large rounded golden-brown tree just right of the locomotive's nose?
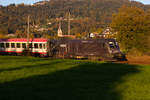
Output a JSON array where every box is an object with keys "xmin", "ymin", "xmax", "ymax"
[{"xmin": 111, "ymin": 6, "xmax": 150, "ymax": 52}]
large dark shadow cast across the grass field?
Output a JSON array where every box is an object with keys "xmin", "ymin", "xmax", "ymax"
[{"xmin": 0, "ymin": 62, "xmax": 139, "ymax": 100}]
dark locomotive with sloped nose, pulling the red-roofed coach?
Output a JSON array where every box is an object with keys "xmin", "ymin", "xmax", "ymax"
[{"xmin": 48, "ymin": 39, "xmax": 127, "ymax": 61}]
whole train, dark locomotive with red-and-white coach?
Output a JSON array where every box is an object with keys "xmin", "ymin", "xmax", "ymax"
[{"xmin": 0, "ymin": 38, "xmax": 127, "ymax": 61}]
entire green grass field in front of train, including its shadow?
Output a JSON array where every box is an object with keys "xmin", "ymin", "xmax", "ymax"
[{"xmin": 0, "ymin": 56, "xmax": 150, "ymax": 100}]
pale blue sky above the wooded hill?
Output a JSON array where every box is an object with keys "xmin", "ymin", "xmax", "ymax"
[{"xmin": 0, "ymin": 0, "xmax": 150, "ymax": 6}]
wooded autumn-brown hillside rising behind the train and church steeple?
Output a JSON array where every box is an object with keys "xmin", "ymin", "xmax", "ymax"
[{"xmin": 0, "ymin": 0, "xmax": 149, "ymax": 36}]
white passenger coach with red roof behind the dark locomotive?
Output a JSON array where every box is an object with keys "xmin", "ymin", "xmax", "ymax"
[{"xmin": 0, "ymin": 38, "xmax": 48, "ymax": 56}]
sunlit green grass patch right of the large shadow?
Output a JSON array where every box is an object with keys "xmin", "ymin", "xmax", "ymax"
[{"xmin": 116, "ymin": 65, "xmax": 150, "ymax": 100}]
